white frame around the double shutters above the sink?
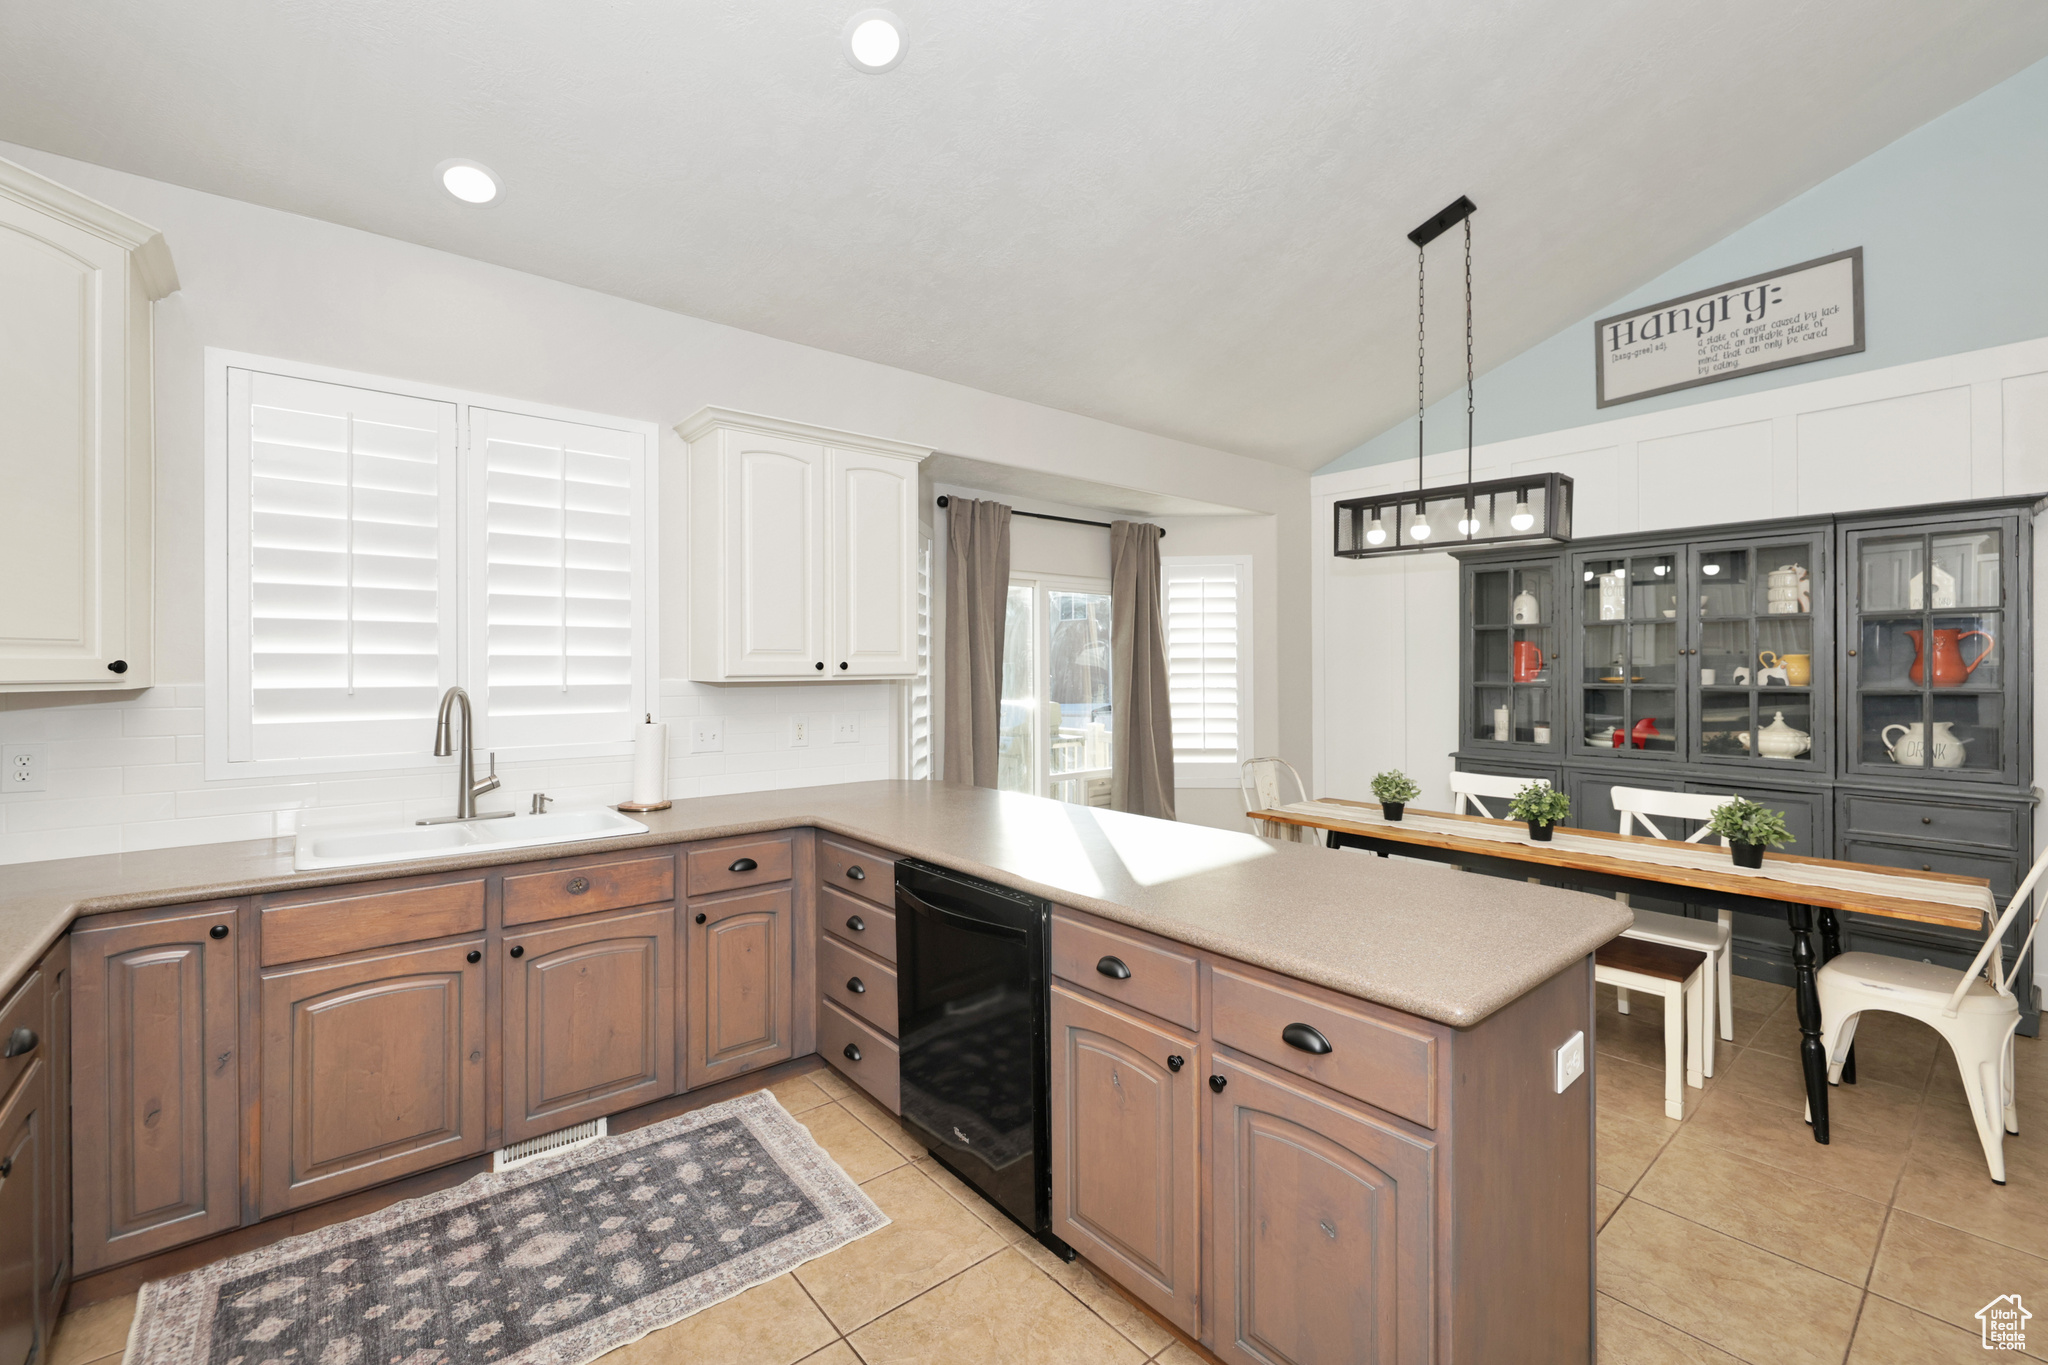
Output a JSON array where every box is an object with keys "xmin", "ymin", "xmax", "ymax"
[{"xmin": 205, "ymin": 346, "xmax": 662, "ymax": 782}]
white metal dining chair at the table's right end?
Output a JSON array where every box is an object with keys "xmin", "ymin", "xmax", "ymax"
[{"xmin": 1817, "ymin": 851, "xmax": 2048, "ymax": 1185}]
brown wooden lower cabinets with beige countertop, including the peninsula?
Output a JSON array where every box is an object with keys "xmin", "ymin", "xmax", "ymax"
[{"xmin": 0, "ymin": 782, "xmax": 1630, "ymax": 1361}]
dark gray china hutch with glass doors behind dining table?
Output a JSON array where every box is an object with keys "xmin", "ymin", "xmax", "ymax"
[{"xmin": 1452, "ymin": 497, "xmax": 2042, "ymax": 1033}]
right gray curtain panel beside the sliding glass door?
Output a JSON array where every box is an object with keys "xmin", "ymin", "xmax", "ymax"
[{"xmin": 1110, "ymin": 522, "xmax": 1174, "ymax": 821}]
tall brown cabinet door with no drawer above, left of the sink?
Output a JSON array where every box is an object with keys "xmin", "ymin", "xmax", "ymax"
[{"xmin": 72, "ymin": 902, "xmax": 242, "ymax": 1273}]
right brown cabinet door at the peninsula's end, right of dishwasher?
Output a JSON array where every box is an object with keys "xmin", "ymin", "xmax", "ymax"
[{"xmin": 1210, "ymin": 1058, "xmax": 1434, "ymax": 1365}]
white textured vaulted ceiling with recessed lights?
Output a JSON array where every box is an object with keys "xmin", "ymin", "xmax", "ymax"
[{"xmin": 0, "ymin": 0, "xmax": 2048, "ymax": 469}]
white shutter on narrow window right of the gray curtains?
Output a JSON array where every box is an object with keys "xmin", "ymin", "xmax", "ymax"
[{"xmin": 1161, "ymin": 559, "xmax": 1245, "ymax": 772}]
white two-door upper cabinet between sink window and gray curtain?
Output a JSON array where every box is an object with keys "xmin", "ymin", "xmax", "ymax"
[{"xmin": 676, "ymin": 407, "xmax": 930, "ymax": 681}]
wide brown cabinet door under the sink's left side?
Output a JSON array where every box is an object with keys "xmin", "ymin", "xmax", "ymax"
[{"xmin": 258, "ymin": 939, "xmax": 483, "ymax": 1218}]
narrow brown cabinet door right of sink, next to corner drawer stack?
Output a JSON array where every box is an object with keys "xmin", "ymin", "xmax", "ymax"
[{"xmin": 688, "ymin": 886, "xmax": 795, "ymax": 1087}]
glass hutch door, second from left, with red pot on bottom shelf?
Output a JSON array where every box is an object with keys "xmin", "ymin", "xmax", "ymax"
[{"xmin": 1573, "ymin": 546, "xmax": 1686, "ymax": 759}]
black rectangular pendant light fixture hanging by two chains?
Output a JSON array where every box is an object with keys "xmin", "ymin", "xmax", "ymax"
[{"xmin": 1335, "ymin": 194, "xmax": 1571, "ymax": 559}]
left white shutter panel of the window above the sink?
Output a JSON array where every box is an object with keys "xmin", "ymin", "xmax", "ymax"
[{"xmin": 225, "ymin": 368, "xmax": 459, "ymax": 767}]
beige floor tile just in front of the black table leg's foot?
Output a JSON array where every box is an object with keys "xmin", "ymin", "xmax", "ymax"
[{"xmin": 1630, "ymin": 1134, "xmax": 1884, "ymax": 1285}]
